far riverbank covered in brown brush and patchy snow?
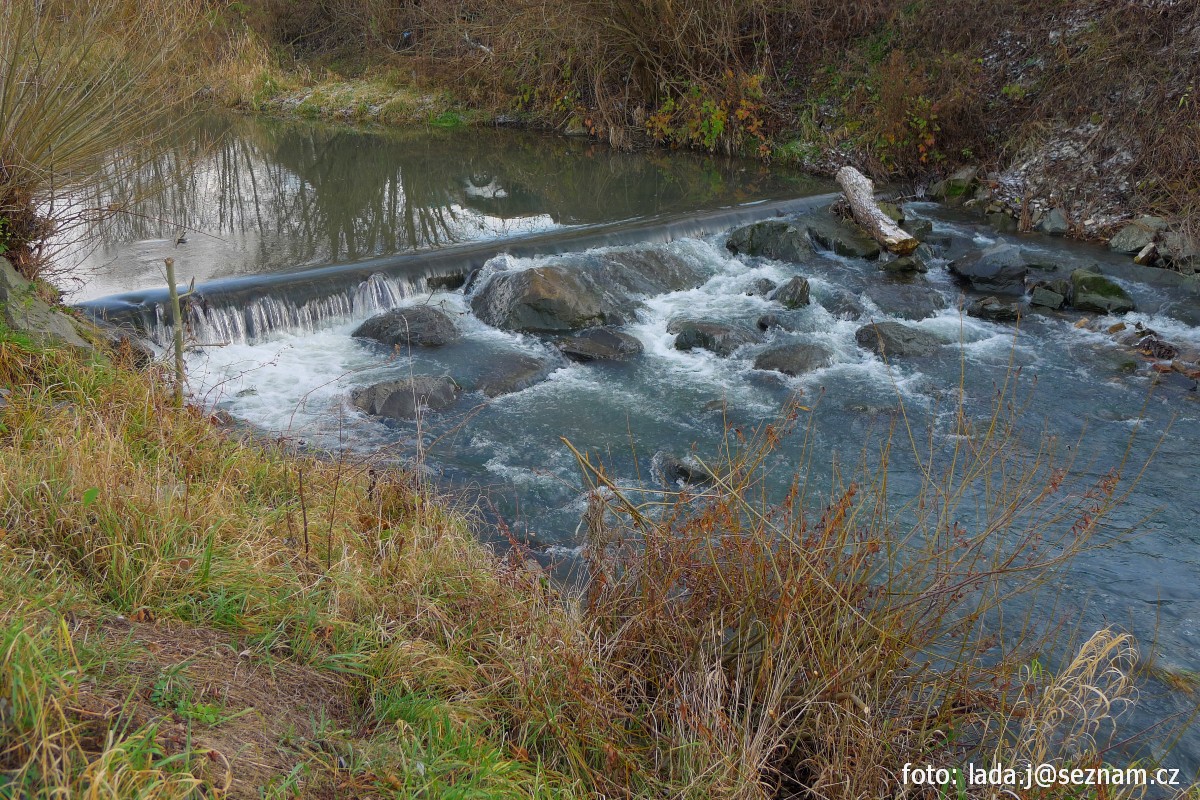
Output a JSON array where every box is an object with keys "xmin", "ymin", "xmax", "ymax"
[{"xmin": 208, "ymin": 0, "xmax": 1200, "ymax": 273}]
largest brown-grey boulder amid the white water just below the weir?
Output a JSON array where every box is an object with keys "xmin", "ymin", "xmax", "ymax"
[{"xmin": 470, "ymin": 247, "xmax": 706, "ymax": 333}]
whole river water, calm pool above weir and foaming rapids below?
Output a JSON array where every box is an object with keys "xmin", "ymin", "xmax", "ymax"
[{"xmin": 77, "ymin": 112, "xmax": 1200, "ymax": 775}]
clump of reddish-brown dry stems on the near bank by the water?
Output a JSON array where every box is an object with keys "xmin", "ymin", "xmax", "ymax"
[{"xmin": 559, "ymin": 381, "xmax": 1152, "ymax": 798}]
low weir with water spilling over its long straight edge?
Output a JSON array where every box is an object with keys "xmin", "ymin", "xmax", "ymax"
[{"xmin": 78, "ymin": 194, "xmax": 836, "ymax": 344}]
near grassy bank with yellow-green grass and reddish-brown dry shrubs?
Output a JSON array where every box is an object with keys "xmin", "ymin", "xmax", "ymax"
[{"xmin": 0, "ymin": 316, "xmax": 1180, "ymax": 798}]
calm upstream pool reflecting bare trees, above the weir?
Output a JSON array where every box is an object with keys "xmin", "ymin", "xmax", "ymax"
[{"xmin": 71, "ymin": 116, "xmax": 814, "ymax": 301}]
